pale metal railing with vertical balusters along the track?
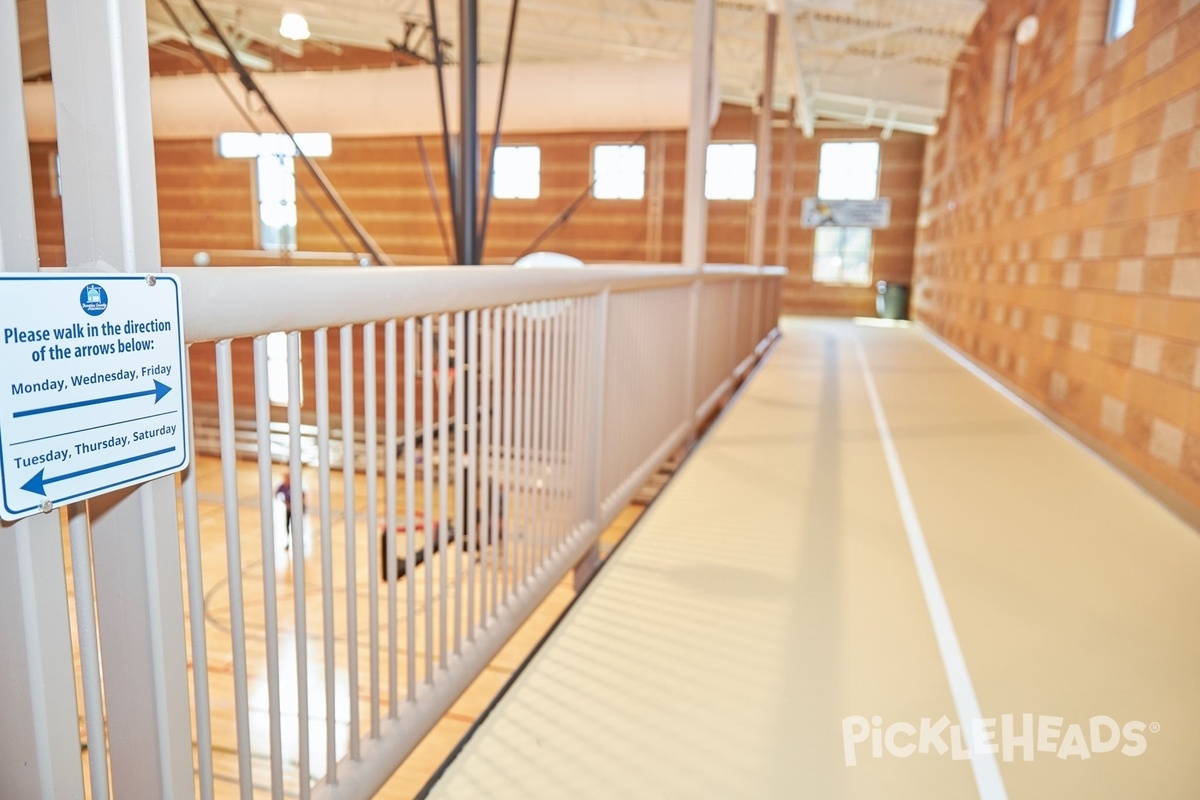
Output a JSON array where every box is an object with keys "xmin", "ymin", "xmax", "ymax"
[{"xmin": 121, "ymin": 267, "xmax": 781, "ymax": 798}]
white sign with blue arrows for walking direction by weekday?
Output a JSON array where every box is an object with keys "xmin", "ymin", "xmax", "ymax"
[{"xmin": 0, "ymin": 272, "xmax": 190, "ymax": 519}]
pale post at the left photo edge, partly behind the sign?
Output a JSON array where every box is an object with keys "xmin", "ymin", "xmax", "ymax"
[{"xmin": 0, "ymin": 0, "xmax": 84, "ymax": 800}]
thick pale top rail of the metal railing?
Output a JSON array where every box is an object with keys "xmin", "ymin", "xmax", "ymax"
[{"xmin": 164, "ymin": 265, "xmax": 782, "ymax": 342}]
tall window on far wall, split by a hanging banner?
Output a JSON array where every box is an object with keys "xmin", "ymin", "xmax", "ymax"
[{"xmin": 812, "ymin": 142, "xmax": 880, "ymax": 285}]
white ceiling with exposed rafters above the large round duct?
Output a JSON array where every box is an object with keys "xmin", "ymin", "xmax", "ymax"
[{"xmin": 17, "ymin": 0, "xmax": 985, "ymax": 136}]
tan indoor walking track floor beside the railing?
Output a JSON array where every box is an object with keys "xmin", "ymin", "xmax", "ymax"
[{"xmin": 426, "ymin": 319, "xmax": 1200, "ymax": 800}]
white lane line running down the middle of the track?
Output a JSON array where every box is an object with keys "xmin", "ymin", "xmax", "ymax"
[{"xmin": 854, "ymin": 337, "xmax": 1008, "ymax": 800}]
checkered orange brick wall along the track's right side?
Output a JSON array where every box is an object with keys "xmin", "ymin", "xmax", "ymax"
[{"xmin": 914, "ymin": 0, "xmax": 1200, "ymax": 513}]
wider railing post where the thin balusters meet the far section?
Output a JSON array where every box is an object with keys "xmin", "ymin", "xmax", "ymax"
[{"xmin": 575, "ymin": 289, "xmax": 610, "ymax": 591}]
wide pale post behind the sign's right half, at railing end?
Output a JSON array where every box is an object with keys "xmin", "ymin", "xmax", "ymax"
[{"xmin": 47, "ymin": 0, "xmax": 194, "ymax": 800}]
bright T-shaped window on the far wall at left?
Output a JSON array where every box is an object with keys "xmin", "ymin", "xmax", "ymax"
[{"xmin": 217, "ymin": 133, "xmax": 334, "ymax": 252}]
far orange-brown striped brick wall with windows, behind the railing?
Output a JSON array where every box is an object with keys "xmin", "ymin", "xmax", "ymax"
[{"xmin": 31, "ymin": 106, "xmax": 925, "ymax": 315}]
